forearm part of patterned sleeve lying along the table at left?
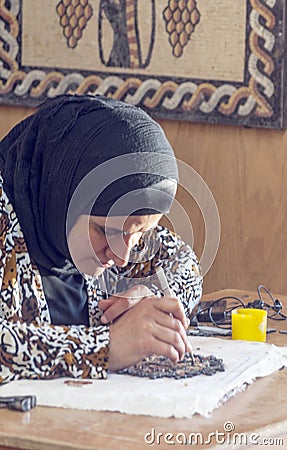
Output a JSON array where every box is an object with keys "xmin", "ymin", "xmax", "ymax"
[{"xmin": 0, "ymin": 319, "xmax": 109, "ymax": 383}]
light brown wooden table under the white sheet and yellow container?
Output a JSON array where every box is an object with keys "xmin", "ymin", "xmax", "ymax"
[{"xmin": 0, "ymin": 290, "xmax": 287, "ymax": 450}]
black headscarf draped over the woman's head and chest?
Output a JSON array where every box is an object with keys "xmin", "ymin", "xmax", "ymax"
[{"xmin": 0, "ymin": 95, "xmax": 178, "ymax": 323}]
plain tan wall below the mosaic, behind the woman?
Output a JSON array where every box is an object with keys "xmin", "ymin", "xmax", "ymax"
[{"xmin": 0, "ymin": 106, "xmax": 287, "ymax": 294}]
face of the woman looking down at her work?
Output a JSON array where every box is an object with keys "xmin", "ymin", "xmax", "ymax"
[{"xmin": 68, "ymin": 214, "xmax": 162, "ymax": 276}]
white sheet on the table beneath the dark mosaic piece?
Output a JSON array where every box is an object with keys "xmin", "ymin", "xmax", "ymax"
[{"xmin": 0, "ymin": 337, "xmax": 287, "ymax": 418}]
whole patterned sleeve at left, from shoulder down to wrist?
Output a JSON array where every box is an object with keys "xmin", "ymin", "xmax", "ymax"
[{"xmin": 0, "ymin": 186, "xmax": 109, "ymax": 384}]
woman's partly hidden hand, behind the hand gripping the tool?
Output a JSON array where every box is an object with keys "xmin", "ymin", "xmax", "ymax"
[{"xmin": 99, "ymin": 285, "xmax": 154, "ymax": 324}]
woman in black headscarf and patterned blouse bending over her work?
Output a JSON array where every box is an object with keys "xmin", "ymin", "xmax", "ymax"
[{"xmin": 0, "ymin": 95, "xmax": 202, "ymax": 382}]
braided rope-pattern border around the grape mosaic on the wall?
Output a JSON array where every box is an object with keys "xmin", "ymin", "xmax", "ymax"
[{"xmin": 0, "ymin": 0, "xmax": 286, "ymax": 128}]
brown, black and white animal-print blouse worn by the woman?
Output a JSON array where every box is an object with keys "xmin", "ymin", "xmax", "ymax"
[{"xmin": 0, "ymin": 175, "xmax": 202, "ymax": 384}]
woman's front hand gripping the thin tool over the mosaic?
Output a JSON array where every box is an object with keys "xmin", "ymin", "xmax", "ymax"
[{"xmin": 109, "ymin": 297, "xmax": 191, "ymax": 371}]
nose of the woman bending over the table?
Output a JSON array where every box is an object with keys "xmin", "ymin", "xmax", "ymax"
[{"xmin": 106, "ymin": 233, "xmax": 140, "ymax": 267}]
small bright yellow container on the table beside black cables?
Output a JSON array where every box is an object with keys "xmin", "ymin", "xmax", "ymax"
[{"xmin": 231, "ymin": 308, "xmax": 267, "ymax": 342}]
